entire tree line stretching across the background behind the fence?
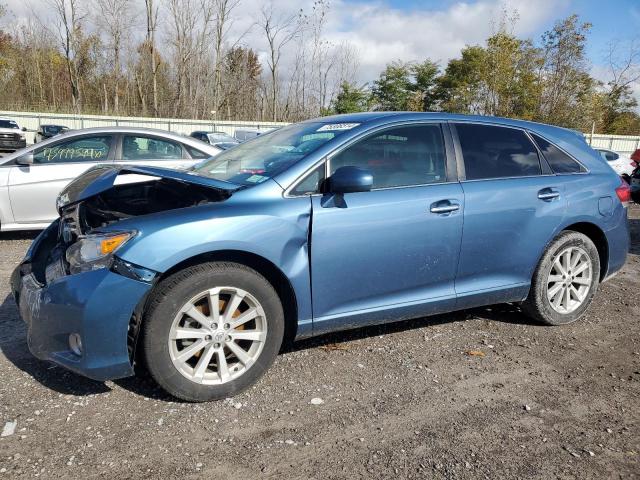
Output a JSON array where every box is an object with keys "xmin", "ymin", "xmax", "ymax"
[{"xmin": 0, "ymin": 0, "xmax": 640, "ymax": 134}]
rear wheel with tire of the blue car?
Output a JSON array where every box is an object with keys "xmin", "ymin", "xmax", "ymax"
[{"xmin": 522, "ymin": 231, "xmax": 600, "ymax": 325}]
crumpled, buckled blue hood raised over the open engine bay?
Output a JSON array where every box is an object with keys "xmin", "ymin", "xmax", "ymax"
[{"xmin": 56, "ymin": 165, "xmax": 241, "ymax": 212}]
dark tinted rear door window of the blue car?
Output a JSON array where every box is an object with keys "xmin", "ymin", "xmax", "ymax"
[{"xmin": 456, "ymin": 123, "xmax": 542, "ymax": 180}]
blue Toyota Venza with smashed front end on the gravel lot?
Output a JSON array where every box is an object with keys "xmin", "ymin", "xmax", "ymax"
[{"xmin": 12, "ymin": 112, "xmax": 629, "ymax": 401}]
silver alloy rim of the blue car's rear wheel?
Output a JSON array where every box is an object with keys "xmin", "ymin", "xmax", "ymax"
[{"xmin": 547, "ymin": 246, "xmax": 593, "ymax": 315}]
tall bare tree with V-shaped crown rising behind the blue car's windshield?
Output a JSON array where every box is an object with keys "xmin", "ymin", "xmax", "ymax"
[{"xmin": 259, "ymin": 4, "xmax": 300, "ymax": 122}]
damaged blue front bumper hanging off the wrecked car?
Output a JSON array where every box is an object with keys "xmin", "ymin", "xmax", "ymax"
[{"xmin": 11, "ymin": 222, "xmax": 153, "ymax": 381}]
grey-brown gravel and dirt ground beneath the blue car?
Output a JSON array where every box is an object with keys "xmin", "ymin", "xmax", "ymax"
[{"xmin": 0, "ymin": 211, "xmax": 640, "ymax": 479}]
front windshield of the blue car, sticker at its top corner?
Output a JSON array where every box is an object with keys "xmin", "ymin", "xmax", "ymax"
[{"xmin": 193, "ymin": 122, "xmax": 358, "ymax": 186}]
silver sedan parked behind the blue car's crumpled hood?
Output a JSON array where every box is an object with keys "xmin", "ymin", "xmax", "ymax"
[{"xmin": 0, "ymin": 127, "xmax": 221, "ymax": 231}]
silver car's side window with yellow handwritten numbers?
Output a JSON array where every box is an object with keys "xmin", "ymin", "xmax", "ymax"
[{"xmin": 33, "ymin": 135, "xmax": 113, "ymax": 164}]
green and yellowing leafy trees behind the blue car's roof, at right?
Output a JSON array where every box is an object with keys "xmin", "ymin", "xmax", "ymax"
[{"xmin": 331, "ymin": 15, "xmax": 640, "ymax": 135}]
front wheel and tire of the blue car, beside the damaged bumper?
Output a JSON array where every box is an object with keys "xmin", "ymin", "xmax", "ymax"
[{"xmin": 142, "ymin": 262, "xmax": 284, "ymax": 402}]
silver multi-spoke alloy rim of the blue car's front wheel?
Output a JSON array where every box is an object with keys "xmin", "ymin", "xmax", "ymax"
[{"xmin": 169, "ymin": 287, "xmax": 267, "ymax": 385}]
